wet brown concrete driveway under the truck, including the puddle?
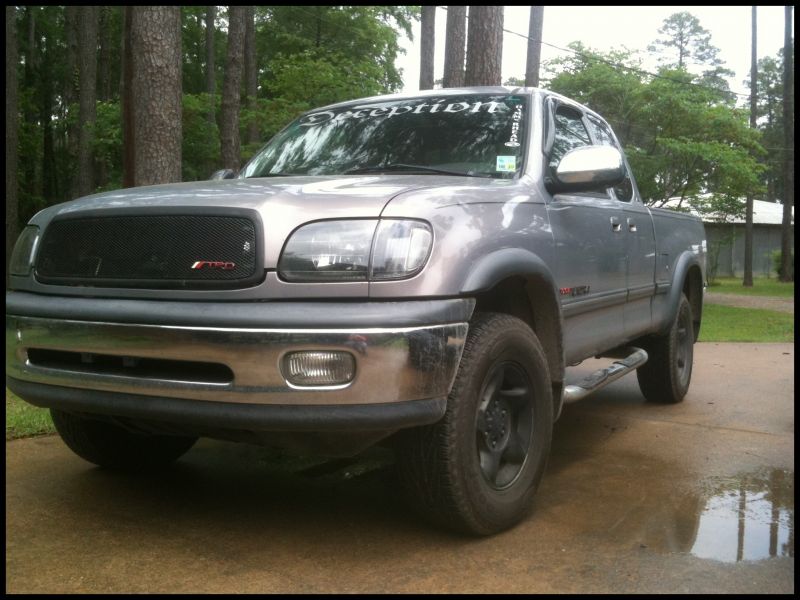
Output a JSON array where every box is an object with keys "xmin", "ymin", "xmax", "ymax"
[{"xmin": 6, "ymin": 344, "xmax": 794, "ymax": 593}]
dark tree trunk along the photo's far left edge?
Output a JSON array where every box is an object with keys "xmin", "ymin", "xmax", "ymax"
[{"xmin": 6, "ymin": 6, "xmax": 19, "ymax": 287}]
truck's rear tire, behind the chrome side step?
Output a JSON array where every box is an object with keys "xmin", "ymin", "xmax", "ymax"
[{"xmin": 636, "ymin": 295, "xmax": 694, "ymax": 404}]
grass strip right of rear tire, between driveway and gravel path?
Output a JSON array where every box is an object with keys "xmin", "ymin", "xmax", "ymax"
[{"xmin": 698, "ymin": 303, "xmax": 794, "ymax": 342}]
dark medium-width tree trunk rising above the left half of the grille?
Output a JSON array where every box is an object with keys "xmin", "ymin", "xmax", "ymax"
[{"xmin": 78, "ymin": 6, "xmax": 97, "ymax": 196}]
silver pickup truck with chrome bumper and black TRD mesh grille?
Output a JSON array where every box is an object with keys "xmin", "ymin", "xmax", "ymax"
[{"xmin": 6, "ymin": 87, "xmax": 706, "ymax": 535}]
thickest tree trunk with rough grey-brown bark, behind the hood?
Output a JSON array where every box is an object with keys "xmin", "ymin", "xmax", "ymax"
[{"xmin": 131, "ymin": 6, "xmax": 183, "ymax": 185}]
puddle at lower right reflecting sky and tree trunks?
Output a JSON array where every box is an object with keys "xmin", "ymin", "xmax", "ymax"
[{"xmin": 691, "ymin": 470, "xmax": 794, "ymax": 562}]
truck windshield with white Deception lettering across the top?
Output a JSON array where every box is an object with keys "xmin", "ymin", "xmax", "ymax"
[{"xmin": 243, "ymin": 94, "xmax": 528, "ymax": 178}]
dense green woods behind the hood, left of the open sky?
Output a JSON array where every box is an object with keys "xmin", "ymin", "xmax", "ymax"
[{"xmin": 6, "ymin": 6, "xmax": 419, "ymax": 223}]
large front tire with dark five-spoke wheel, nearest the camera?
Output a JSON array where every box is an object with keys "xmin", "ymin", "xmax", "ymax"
[{"xmin": 397, "ymin": 313, "xmax": 553, "ymax": 535}]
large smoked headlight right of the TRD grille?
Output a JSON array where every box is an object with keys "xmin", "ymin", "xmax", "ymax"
[{"xmin": 278, "ymin": 219, "xmax": 433, "ymax": 282}]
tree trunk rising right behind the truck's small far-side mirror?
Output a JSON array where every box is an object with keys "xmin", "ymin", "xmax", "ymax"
[{"xmin": 220, "ymin": 6, "xmax": 245, "ymax": 171}]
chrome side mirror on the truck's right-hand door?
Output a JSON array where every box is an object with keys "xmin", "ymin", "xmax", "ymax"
[{"xmin": 547, "ymin": 146, "xmax": 625, "ymax": 194}]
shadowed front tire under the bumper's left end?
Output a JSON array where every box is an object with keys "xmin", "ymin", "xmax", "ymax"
[{"xmin": 50, "ymin": 408, "xmax": 197, "ymax": 470}]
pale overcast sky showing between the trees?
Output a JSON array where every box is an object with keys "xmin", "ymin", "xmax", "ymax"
[{"xmin": 397, "ymin": 6, "xmax": 784, "ymax": 101}]
